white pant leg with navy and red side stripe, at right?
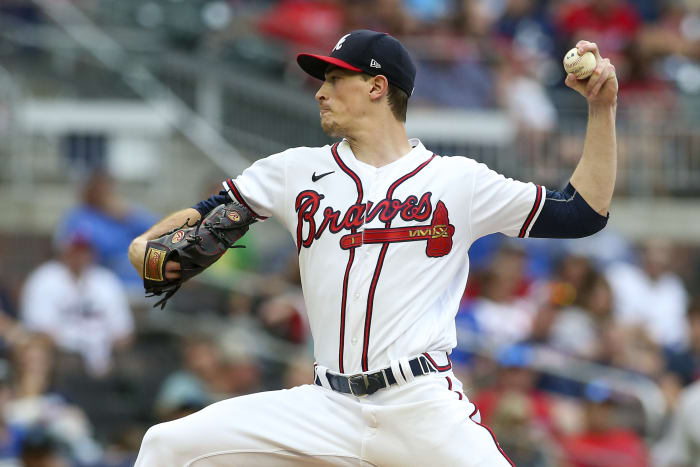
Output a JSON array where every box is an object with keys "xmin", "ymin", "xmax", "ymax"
[{"xmin": 365, "ymin": 372, "xmax": 512, "ymax": 467}]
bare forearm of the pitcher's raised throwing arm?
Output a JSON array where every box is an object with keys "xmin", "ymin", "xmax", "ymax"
[{"xmin": 571, "ymin": 104, "xmax": 617, "ymax": 216}]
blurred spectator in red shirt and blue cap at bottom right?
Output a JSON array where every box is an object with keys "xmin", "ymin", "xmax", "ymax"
[{"xmin": 563, "ymin": 382, "xmax": 648, "ymax": 467}]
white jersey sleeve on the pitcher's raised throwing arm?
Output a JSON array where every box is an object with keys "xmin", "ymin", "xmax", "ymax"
[{"xmin": 470, "ymin": 164, "xmax": 545, "ymax": 240}]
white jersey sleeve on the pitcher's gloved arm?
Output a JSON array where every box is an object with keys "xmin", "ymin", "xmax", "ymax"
[{"xmin": 223, "ymin": 152, "xmax": 287, "ymax": 221}]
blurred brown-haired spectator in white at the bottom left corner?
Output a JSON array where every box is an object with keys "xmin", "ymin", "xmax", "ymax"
[{"xmin": 4, "ymin": 334, "xmax": 101, "ymax": 465}]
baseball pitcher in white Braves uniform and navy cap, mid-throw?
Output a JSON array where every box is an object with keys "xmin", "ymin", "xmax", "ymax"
[{"xmin": 130, "ymin": 30, "xmax": 617, "ymax": 467}]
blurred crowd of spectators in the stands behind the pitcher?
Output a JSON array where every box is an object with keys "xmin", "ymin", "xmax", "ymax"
[{"xmin": 0, "ymin": 0, "xmax": 700, "ymax": 467}]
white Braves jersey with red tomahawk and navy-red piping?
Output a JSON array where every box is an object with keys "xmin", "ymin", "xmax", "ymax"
[{"xmin": 224, "ymin": 139, "xmax": 545, "ymax": 374}]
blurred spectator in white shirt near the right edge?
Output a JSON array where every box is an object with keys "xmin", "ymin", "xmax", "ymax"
[{"xmin": 606, "ymin": 239, "xmax": 688, "ymax": 349}]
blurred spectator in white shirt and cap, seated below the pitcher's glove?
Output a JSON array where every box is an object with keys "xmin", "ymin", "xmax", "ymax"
[{"xmin": 21, "ymin": 232, "xmax": 134, "ymax": 376}]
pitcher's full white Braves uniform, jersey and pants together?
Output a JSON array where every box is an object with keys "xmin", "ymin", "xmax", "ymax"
[{"xmin": 136, "ymin": 140, "xmax": 544, "ymax": 467}]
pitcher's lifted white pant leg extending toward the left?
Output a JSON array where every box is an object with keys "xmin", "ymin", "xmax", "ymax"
[{"xmin": 136, "ymin": 385, "xmax": 371, "ymax": 467}]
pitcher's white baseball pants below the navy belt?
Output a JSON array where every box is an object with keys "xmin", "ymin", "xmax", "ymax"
[{"xmin": 136, "ymin": 371, "xmax": 512, "ymax": 467}]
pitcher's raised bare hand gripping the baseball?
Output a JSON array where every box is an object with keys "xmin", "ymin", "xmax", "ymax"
[{"xmin": 564, "ymin": 41, "xmax": 618, "ymax": 106}]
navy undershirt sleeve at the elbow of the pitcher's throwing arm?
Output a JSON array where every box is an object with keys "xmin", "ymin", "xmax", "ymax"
[{"xmin": 530, "ymin": 183, "xmax": 610, "ymax": 238}]
